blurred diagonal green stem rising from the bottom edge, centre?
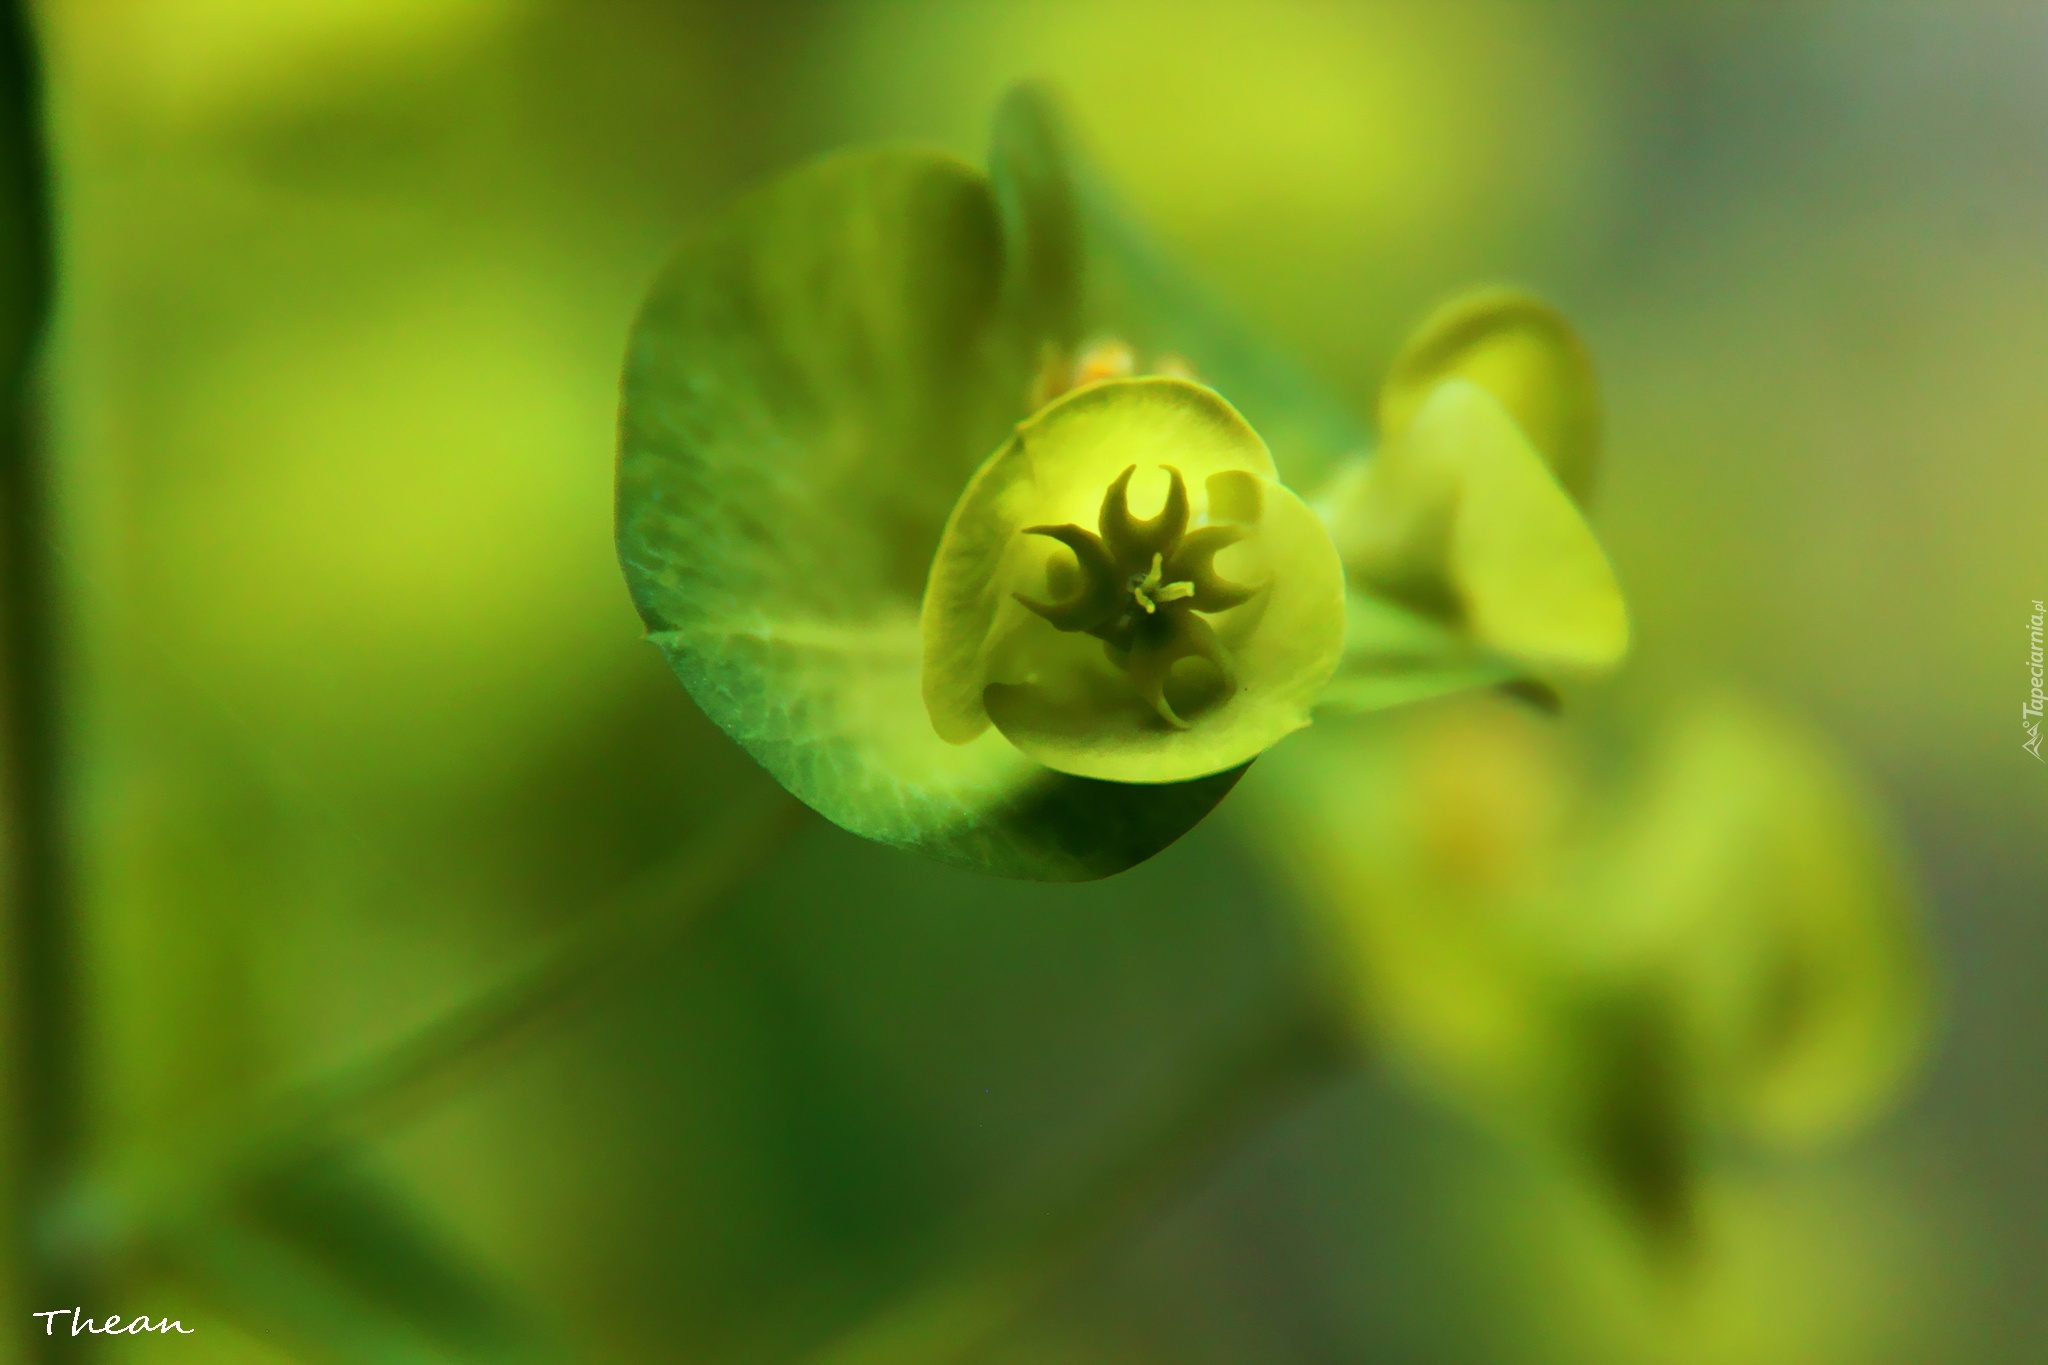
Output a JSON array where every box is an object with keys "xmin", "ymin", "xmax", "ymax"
[{"xmin": 809, "ymin": 999, "xmax": 1358, "ymax": 1365}]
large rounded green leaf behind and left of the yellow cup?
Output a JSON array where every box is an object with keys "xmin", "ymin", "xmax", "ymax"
[{"xmin": 618, "ymin": 151, "xmax": 1235, "ymax": 880}]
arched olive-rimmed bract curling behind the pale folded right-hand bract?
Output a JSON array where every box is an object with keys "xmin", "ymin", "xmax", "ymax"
[{"xmin": 1380, "ymin": 287, "xmax": 1599, "ymax": 508}]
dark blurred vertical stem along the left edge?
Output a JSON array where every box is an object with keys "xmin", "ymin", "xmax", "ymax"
[{"xmin": 0, "ymin": 2, "xmax": 86, "ymax": 1359}]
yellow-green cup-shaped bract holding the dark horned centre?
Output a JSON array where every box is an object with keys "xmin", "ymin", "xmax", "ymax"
[{"xmin": 922, "ymin": 377, "xmax": 1343, "ymax": 784}]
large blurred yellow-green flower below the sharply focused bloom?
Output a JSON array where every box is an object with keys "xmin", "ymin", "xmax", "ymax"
[{"xmin": 1247, "ymin": 700, "xmax": 1929, "ymax": 1234}]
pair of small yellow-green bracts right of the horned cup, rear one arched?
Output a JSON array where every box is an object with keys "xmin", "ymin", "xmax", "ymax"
[{"xmin": 1317, "ymin": 289, "xmax": 1628, "ymax": 710}]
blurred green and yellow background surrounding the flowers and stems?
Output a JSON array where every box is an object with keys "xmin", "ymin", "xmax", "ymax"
[{"xmin": 8, "ymin": 0, "xmax": 2048, "ymax": 1365}]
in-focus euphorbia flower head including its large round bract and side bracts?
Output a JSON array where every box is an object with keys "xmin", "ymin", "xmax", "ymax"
[{"xmin": 618, "ymin": 90, "xmax": 1618, "ymax": 880}]
